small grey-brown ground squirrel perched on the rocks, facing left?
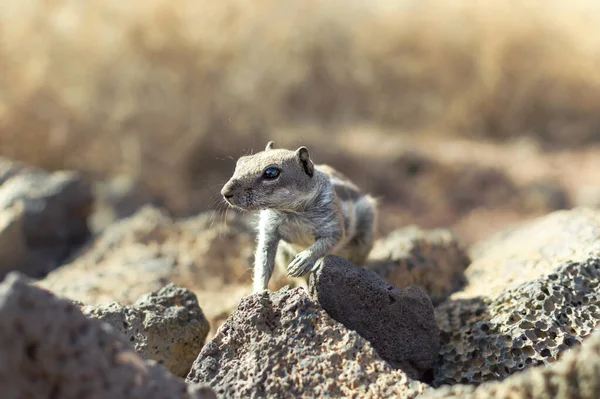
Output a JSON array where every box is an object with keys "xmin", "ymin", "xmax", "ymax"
[{"xmin": 221, "ymin": 141, "xmax": 376, "ymax": 292}]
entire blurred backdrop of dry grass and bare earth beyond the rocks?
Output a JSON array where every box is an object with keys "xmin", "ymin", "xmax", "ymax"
[{"xmin": 0, "ymin": 0, "xmax": 600, "ymax": 243}]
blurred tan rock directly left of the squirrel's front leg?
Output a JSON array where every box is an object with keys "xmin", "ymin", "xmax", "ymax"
[{"xmin": 39, "ymin": 207, "xmax": 254, "ymax": 334}]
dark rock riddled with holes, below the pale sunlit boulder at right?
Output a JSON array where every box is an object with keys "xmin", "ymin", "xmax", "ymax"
[{"xmin": 436, "ymin": 259, "xmax": 600, "ymax": 383}]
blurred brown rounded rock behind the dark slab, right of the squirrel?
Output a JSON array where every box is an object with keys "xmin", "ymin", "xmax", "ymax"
[{"xmin": 365, "ymin": 226, "xmax": 470, "ymax": 304}]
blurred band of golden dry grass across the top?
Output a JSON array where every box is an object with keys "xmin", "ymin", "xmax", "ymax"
[{"xmin": 0, "ymin": 0, "xmax": 600, "ymax": 209}]
